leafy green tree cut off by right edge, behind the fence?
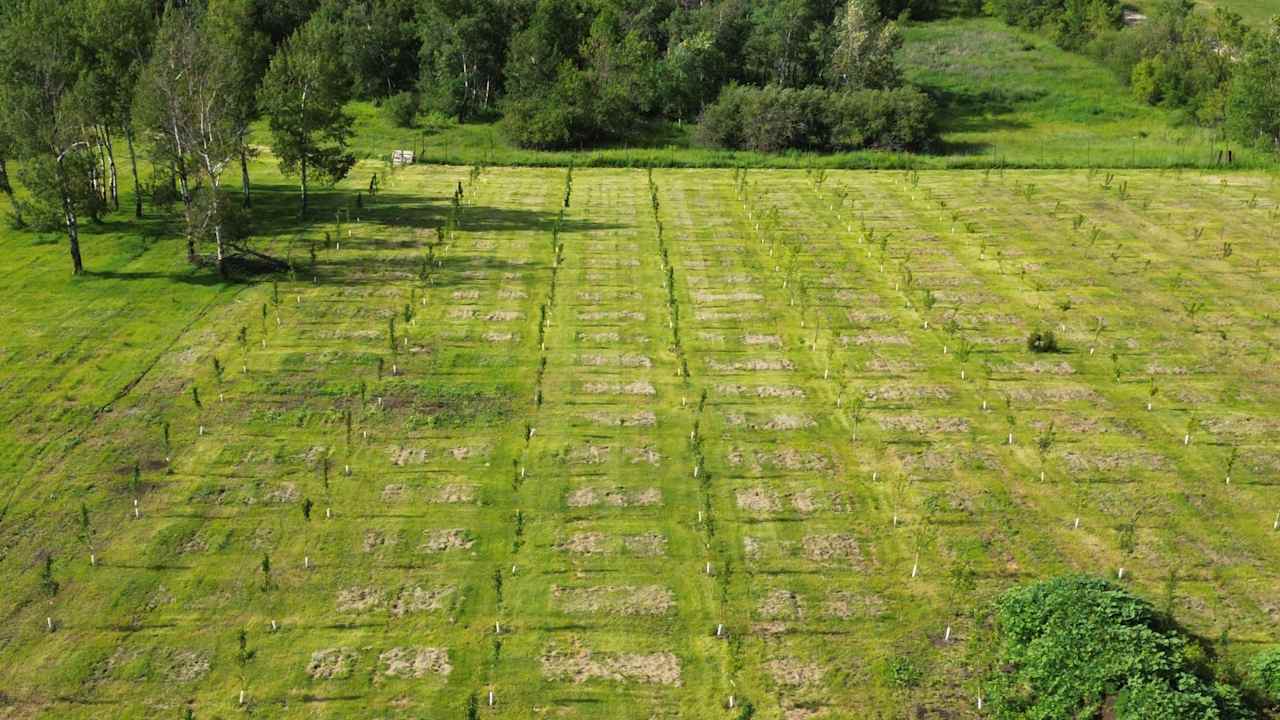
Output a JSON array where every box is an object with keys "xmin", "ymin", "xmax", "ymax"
[{"xmin": 1228, "ymin": 15, "xmax": 1280, "ymax": 152}]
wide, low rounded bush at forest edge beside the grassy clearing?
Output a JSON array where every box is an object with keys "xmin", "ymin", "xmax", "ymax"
[{"xmin": 698, "ymin": 83, "xmax": 934, "ymax": 152}]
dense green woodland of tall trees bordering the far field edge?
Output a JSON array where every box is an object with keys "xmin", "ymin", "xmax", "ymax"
[{"xmin": 0, "ymin": 0, "xmax": 1280, "ymax": 272}]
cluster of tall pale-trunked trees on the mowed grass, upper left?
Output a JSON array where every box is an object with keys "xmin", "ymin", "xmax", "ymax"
[{"xmin": 0, "ymin": 0, "xmax": 355, "ymax": 274}]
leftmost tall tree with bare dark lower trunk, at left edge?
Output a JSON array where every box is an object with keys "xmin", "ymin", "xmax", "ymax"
[{"xmin": 0, "ymin": 0, "xmax": 96, "ymax": 275}]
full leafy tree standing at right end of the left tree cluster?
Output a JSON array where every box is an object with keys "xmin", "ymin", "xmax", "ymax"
[{"xmin": 257, "ymin": 15, "xmax": 356, "ymax": 215}]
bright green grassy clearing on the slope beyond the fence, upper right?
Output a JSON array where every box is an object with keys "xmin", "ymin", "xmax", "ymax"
[{"xmin": 901, "ymin": 18, "xmax": 1267, "ymax": 168}]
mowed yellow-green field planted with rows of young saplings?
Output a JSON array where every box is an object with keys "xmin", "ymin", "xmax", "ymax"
[{"xmin": 0, "ymin": 163, "xmax": 1280, "ymax": 719}]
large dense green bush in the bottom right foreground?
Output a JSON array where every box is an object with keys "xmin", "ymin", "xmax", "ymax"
[{"xmin": 987, "ymin": 575, "xmax": 1253, "ymax": 720}]
